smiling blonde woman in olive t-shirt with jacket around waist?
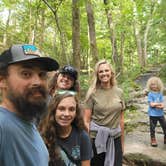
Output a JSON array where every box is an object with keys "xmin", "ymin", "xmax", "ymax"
[{"xmin": 84, "ymin": 60, "xmax": 125, "ymax": 166}]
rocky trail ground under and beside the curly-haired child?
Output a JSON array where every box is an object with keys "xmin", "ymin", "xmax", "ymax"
[{"xmin": 123, "ymin": 67, "xmax": 166, "ymax": 166}]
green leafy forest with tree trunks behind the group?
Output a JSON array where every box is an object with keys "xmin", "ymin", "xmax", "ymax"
[{"xmin": 0, "ymin": 0, "xmax": 166, "ymax": 100}]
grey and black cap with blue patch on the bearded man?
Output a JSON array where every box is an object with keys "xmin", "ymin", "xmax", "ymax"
[{"xmin": 0, "ymin": 44, "xmax": 59, "ymax": 71}]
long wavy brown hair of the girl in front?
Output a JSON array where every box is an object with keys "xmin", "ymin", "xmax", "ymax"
[{"xmin": 39, "ymin": 91, "xmax": 85, "ymax": 166}]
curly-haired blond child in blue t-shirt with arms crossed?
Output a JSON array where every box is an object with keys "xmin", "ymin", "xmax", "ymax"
[{"xmin": 147, "ymin": 77, "xmax": 166, "ymax": 147}]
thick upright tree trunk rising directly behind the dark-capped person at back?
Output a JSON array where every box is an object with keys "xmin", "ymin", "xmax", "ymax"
[{"xmin": 72, "ymin": 0, "xmax": 80, "ymax": 71}]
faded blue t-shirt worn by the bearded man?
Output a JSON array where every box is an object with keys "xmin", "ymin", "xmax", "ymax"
[{"xmin": 0, "ymin": 107, "xmax": 49, "ymax": 166}]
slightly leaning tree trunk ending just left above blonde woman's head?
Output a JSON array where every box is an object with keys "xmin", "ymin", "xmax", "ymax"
[{"xmin": 86, "ymin": 0, "xmax": 98, "ymax": 63}]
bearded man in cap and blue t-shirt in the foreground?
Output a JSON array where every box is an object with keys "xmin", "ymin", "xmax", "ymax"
[{"xmin": 0, "ymin": 44, "xmax": 59, "ymax": 166}]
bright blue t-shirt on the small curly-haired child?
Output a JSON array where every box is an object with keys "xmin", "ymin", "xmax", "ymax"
[{"xmin": 148, "ymin": 92, "xmax": 164, "ymax": 117}]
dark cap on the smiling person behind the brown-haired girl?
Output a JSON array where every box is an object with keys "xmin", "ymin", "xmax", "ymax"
[{"xmin": 59, "ymin": 65, "xmax": 78, "ymax": 80}]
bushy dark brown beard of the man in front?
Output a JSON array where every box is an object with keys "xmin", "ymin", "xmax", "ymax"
[{"xmin": 7, "ymin": 86, "xmax": 48, "ymax": 120}]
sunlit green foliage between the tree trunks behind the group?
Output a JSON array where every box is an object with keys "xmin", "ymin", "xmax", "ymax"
[{"xmin": 0, "ymin": 0, "xmax": 166, "ymax": 79}]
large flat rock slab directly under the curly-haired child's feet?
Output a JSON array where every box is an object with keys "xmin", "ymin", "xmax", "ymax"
[{"xmin": 124, "ymin": 131, "xmax": 166, "ymax": 166}]
